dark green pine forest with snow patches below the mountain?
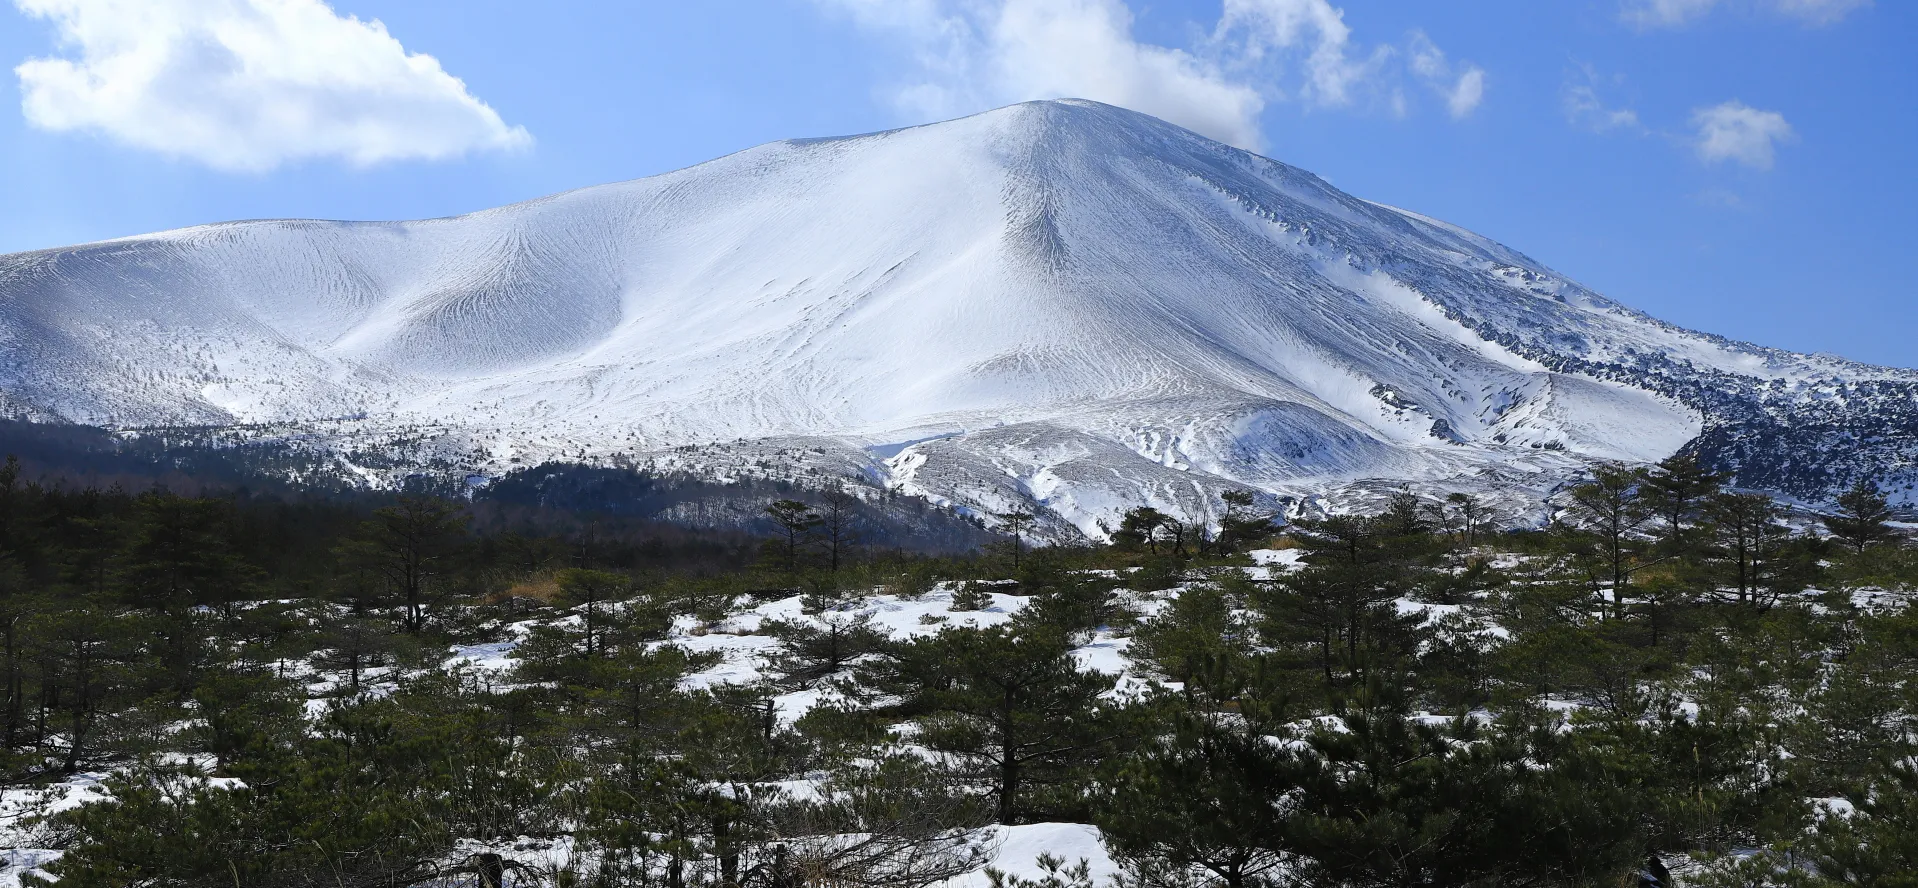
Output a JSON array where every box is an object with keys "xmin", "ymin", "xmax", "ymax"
[{"xmin": 0, "ymin": 458, "xmax": 1918, "ymax": 888}]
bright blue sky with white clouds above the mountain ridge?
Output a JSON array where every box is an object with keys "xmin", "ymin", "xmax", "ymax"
[{"xmin": 0, "ymin": 0, "xmax": 1918, "ymax": 366}]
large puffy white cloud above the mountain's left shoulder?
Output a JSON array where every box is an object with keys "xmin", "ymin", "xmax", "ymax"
[{"xmin": 13, "ymin": 0, "xmax": 531, "ymax": 171}]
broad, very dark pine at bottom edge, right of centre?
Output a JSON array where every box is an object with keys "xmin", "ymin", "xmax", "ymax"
[{"xmin": 1279, "ymin": 694, "xmax": 1642, "ymax": 888}]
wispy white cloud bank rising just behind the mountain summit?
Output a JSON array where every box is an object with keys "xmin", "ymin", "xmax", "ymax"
[{"xmin": 817, "ymin": 0, "xmax": 1485, "ymax": 150}]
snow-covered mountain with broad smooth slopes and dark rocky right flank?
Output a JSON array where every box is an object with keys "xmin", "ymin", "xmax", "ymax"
[{"xmin": 0, "ymin": 100, "xmax": 1918, "ymax": 531}]
